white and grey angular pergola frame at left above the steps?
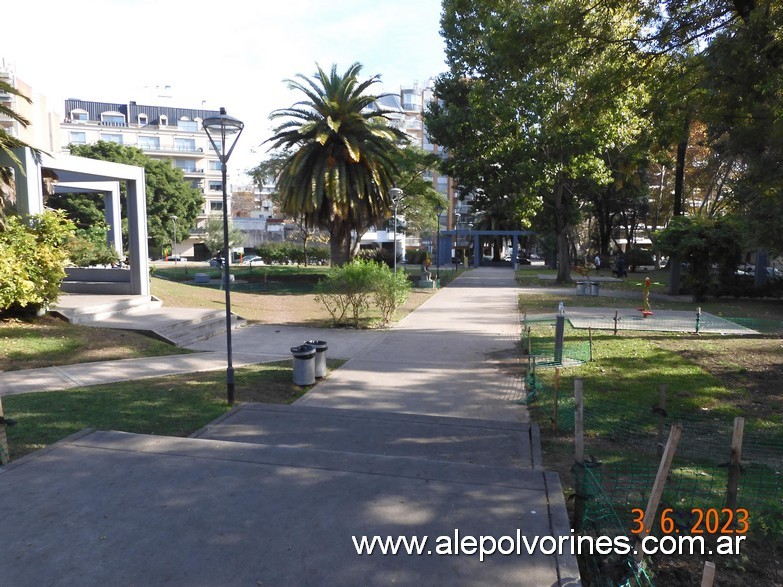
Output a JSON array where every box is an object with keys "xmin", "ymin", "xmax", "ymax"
[{"xmin": 0, "ymin": 149, "xmax": 150, "ymax": 296}]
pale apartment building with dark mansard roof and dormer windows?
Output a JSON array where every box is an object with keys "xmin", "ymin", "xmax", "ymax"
[{"xmin": 59, "ymin": 99, "xmax": 231, "ymax": 259}]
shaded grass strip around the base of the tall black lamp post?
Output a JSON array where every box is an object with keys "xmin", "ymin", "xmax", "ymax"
[{"xmin": 3, "ymin": 360, "xmax": 341, "ymax": 460}]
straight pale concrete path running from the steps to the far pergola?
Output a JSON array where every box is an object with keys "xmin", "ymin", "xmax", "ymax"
[{"xmin": 298, "ymin": 268, "xmax": 527, "ymax": 421}]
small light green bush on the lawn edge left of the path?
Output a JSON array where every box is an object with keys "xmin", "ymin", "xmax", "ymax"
[{"xmin": 315, "ymin": 259, "xmax": 410, "ymax": 328}]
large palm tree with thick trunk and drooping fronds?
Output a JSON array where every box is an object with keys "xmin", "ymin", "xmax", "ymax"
[{"xmin": 267, "ymin": 63, "xmax": 405, "ymax": 265}]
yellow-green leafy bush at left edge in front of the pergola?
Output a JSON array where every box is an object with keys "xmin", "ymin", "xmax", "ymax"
[{"xmin": 0, "ymin": 211, "xmax": 74, "ymax": 311}]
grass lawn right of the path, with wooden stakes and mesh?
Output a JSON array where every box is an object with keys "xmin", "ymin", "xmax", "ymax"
[{"xmin": 518, "ymin": 276, "xmax": 783, "ymax": 585}]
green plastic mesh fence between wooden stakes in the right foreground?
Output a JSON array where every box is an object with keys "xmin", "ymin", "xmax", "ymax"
[{"xmin": 527, "ymin": 374, "xmax": 783, "ymax": 585}]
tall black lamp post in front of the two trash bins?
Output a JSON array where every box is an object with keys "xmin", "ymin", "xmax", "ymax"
[{"xmin": 201, "ymin": 108, "xmax": 245, "ymax": 406}]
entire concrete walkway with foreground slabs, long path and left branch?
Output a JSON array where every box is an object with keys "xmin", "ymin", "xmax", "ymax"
[{"xmin": 0, "ymin": 268, "xmax": 579, "ymax": 587}]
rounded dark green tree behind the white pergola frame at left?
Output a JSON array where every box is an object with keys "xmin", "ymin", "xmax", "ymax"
[{"xmin": 63, "ymin": 141, "xmax": 204, "ymax": 250}]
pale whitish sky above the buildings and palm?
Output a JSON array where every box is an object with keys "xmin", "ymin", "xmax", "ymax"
[{"xmin": 0, "ymin": 0, "xmax": 446, "ymax": 179}]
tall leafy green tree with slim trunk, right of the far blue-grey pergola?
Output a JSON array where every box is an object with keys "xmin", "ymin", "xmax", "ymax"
[{"xmin": 428, "ymin": 0, "xmax": 647, "ymax": 282}]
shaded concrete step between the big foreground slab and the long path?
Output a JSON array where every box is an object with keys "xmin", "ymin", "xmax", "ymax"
[{"xmin": 192, "ymin": 403, "xmax": 541, "ymax": 470}]
